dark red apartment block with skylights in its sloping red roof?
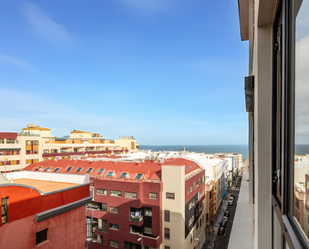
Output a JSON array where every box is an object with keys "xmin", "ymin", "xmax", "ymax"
[{"xmin": 25, "ymin": 156, "xmax": 206, "ymax": 249}]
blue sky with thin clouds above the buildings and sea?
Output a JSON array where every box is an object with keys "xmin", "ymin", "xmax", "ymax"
[{"xmin": 0, "ymin": 0, "xmax": 248, "ymax": 145}]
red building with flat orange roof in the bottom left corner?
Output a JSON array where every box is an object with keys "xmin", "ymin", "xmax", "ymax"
[{"xmin": 0, "ymin": 171, "xmax": 91, "ymax": 249}]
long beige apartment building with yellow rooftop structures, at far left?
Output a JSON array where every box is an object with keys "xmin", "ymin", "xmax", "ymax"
[{"xmin": 0, "ymin": 124, "xmax": 139, "ymax": 172}]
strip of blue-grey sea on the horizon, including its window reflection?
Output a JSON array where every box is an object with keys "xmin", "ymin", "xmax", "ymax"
[{"xmin": 139, "ymin": 144, "xmax": 309, "ymax": 160}]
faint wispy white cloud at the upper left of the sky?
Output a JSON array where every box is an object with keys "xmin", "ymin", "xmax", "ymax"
[{"xmin": 23, "ymin": 2, "xmax": 73, "ymax": 45}]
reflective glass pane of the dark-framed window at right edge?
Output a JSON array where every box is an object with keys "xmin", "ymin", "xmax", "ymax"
[{"xmin": 293, "ymin": 0, "xmax": 309, "ymax": 241}]
